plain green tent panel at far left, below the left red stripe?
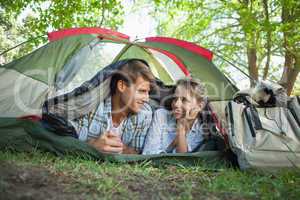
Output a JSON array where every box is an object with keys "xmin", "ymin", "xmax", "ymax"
[{"xmin": 1, "ymin": 35, "xmax": 95, "ymax": 85}]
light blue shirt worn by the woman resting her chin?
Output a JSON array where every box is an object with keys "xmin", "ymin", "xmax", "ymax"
[{"xmin": 143, "ymin": 108, "xmax": 203, "ymax": 154}]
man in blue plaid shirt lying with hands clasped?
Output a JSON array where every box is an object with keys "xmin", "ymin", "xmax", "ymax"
[{"xmin": 77, "ymin": 59, "xmax": 154, "ymax": 154}]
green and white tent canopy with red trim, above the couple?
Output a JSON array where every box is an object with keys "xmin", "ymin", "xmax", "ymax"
[{"xmin": 0, "ymin": 28, "xmax": 237, "ymax": 165}]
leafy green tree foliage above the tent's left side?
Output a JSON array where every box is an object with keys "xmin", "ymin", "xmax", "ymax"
[{"xmin": 0, "ymin": 0, "xmax": 124, "ymax": 63}]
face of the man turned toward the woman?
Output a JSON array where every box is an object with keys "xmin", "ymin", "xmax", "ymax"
[{"xmin": 121, "ymin": 76, "xmax": 150, "ymax": 113}]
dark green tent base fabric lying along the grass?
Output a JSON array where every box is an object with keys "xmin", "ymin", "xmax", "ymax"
[{"xmin": 0, "ymin": 118, "xmax": 222, "ymax": 165}]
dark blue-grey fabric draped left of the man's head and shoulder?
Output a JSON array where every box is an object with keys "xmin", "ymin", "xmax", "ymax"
[{"xmin": 43, "ymin": 59, "xmax": 132, "ymax": 120}]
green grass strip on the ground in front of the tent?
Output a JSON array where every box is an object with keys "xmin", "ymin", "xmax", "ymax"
[{"xmin": 0, "ymin": 151, "xmax": 300, "ymax": 199}]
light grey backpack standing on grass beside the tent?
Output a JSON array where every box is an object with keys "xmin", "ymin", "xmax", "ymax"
[{"xmin": 226, "ymin": 95, "xmax": 300, "ymax": 169}]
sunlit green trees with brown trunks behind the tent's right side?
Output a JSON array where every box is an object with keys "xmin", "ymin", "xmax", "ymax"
[{"xmin": 155, "ymin": 0, "xmax": 300, "ymax": 93}]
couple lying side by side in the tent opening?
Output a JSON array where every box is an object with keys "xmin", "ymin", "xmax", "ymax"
[{"xmin": 44, "ymin": 59, "xmax": 223, "ymax": 154}]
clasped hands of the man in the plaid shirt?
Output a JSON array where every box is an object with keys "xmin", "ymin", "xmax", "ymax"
[{"xmin": 88, "ymin": 131, "xmax": 123, "ymax": 153}]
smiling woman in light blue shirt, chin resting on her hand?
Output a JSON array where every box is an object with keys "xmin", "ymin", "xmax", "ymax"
[{"xmin": 143, "ymin": 79, "xmax": 209, "ymax": 154}]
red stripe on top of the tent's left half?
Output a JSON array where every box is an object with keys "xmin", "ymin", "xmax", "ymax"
[{"xmin": 48, "ymin": 28, "xmax": 129, "ymax": 42}]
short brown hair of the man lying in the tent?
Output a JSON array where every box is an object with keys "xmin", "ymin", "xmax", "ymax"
[{"xmin": 110, "ymin": 59, "xmax": 154, "ymax": 95}]
